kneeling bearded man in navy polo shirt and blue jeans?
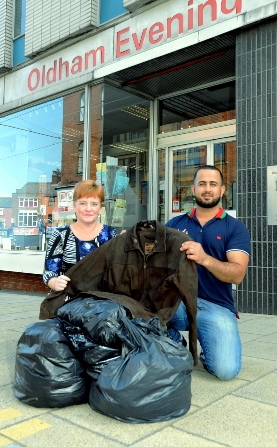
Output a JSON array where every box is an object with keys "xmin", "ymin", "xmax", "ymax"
[{"xmin": 166, "ymin": 165, "xmax": 250, "ymax": 380}]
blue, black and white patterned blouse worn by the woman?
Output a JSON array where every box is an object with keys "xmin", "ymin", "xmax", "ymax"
[{"xmin": 43, "ymin": 224, "xmax": 116, "ymax": 284}]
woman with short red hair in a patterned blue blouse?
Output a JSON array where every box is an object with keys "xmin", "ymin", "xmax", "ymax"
[{"xmin": 43, "ymin": 180, "xmax": 116, "ymax": 292}]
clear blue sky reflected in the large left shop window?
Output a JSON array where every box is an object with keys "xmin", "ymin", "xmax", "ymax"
[{"xmin": 0, "ymin": 98, "xmax": 63, "ymax": 197}]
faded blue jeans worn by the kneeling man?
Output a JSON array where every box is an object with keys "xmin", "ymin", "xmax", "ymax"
[{"xmin": 170, "ymin": 298, "xmax": 242, "ymax": 380}]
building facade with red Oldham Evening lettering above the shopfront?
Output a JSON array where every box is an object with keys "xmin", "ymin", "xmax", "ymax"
[{"xmin": 0, "ymin": 0, "xmax": 277, "ymax": 314}]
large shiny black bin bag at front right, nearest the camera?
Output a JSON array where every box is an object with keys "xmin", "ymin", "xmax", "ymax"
[{"xmin": 89, "ymin": 317, "xmax": 193, "ymax": 423}]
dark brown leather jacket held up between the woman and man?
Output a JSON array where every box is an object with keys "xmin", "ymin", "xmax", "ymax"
[{"xmin": 39, "ymin": 221, "xmax": 198, "ymax": 363}]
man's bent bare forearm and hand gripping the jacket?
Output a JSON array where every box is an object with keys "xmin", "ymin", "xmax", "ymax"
[{"xmin": 180, "ymin": 241, "xmax": 249, "ymax": 284}]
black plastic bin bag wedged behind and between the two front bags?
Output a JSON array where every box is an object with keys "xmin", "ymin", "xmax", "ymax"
[{"xmin": 58, "ymin": 294, "xmax": 127, "ymax": 380}]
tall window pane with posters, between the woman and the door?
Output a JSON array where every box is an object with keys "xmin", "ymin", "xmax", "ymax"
[{"xmin": 97, "ymin": 84, "xmax": 150, "ymax": 229}]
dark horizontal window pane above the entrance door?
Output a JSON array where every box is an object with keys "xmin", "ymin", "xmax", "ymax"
[{"xmin": 160, "ymin": 81, "xmax": 236, "ymax": 133}]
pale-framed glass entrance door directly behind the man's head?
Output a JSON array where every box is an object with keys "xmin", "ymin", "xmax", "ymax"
[{"xmin": 158, "ymin": 138, "xmax": 236, "ymax": 223}]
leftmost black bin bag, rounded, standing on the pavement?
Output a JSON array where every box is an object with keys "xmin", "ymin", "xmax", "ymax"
[{"xmin": 14, "ymin": 318, "xmax": 90, "ymax": 408}]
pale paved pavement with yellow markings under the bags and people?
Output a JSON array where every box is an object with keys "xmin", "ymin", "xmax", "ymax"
[{"xmin": 0, "ymin": 290, "xmax": 277, "ymax": 447}]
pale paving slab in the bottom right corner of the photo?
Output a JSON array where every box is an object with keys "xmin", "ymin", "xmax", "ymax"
[{"xmin": 173, "ymin": 396, "xmax": 277, "ymax": 447}]
